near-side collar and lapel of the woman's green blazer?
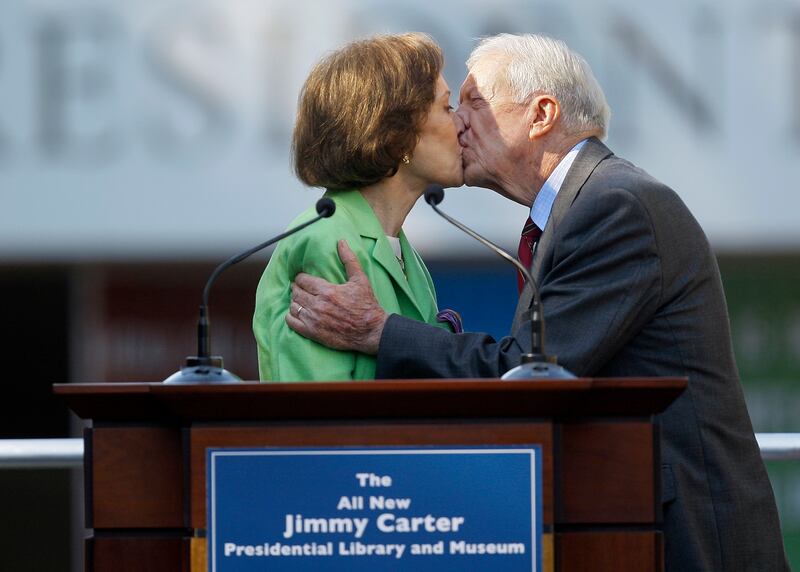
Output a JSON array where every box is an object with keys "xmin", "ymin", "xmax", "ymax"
[{"xmin": 335, "ymin": 191, "xmax": 424, "ymax": 319}]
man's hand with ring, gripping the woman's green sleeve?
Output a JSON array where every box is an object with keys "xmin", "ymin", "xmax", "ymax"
[{"xmin": 286, "ymin": 240, "xmax": 389, "ymax": 355}]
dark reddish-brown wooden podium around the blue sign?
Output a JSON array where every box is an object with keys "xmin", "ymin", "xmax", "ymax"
[{"xmin": 55, "ymin": 378, "xmax": 686, "ymax": 572}]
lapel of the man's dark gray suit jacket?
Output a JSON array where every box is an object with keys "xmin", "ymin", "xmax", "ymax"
[{"xmin": 511, "ymin": 137, "xmax": 613, "ymax": 334}]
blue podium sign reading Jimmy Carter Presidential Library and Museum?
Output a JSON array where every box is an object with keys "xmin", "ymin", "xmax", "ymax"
[{"xmin": 206, "ymin": 445, "xmax": 542, "ymax": 572}]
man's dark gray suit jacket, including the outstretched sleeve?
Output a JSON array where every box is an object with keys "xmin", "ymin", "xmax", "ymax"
[{"xmin": 376, "ymin": 138, "xmax": 788, "ymax": 571}]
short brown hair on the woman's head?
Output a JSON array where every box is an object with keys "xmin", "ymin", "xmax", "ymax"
[{"xmin": 292, "ymin": 33, "xmax": 444, "ymax": 190}]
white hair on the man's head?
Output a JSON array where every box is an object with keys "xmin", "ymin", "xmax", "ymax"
[{"xmin": 467, "ymin": 34, "xmax": 611, "ymax": 138}]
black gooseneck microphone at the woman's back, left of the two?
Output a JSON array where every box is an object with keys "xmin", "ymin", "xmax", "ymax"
[{"xmin": 164, "ymin": 197, "xmax": 336, "ymax": 383}]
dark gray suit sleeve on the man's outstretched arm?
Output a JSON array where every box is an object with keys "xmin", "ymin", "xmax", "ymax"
[{"xmin": 376, "ymin": 188, "xmax": 661, "ymax": 378}]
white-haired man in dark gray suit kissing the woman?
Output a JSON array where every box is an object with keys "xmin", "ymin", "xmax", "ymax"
[{"xmin": 286, "ymin": 35, "xmax": 788, "ymax": 571}]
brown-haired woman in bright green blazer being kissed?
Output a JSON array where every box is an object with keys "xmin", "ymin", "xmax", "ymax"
[{"xmin": 253, "ymin": 33, "xmax": 463, "ymax": 381}]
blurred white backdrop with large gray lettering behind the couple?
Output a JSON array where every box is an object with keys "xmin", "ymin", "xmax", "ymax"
[{"xmin": 0, "ymin": 0, "xmax": 800, "ymax": 261}]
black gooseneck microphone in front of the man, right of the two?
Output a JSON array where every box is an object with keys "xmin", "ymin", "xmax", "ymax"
[{"xmin": 425, "ymin": 184, "xmax": 575, "ymax": 380}]
